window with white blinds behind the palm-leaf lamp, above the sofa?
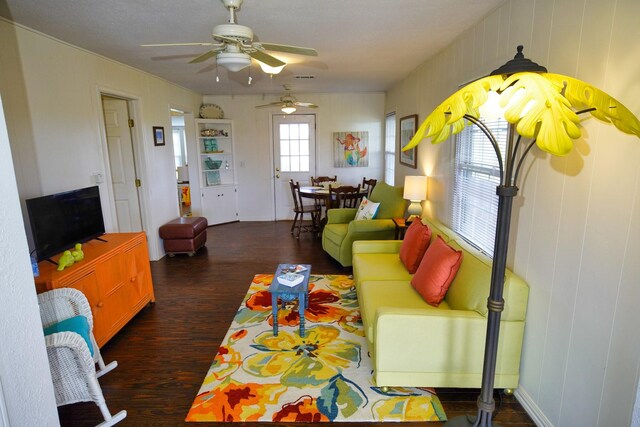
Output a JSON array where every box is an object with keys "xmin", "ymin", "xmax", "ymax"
[{"xmin": 451, "ymin": 119, "xmax": 509, "ymax": 256}]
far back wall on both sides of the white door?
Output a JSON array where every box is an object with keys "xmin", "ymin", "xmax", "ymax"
[{"xmin": 201, "ymin": 93, "xmax": 385, "ymax": 221}]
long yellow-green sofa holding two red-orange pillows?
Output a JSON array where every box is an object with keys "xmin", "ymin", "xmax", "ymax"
[{"xmin": 353, "ymin": 218, "xmax": 529, "ymax": 388}]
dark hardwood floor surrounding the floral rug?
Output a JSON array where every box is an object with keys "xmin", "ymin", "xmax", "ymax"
[{"xmin": 58, "ymin": 221, "xmax": 535, "ymax": 426}]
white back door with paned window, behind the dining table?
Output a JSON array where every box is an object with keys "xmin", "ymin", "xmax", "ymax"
[{"xmin": 273, "ymin": 114, "xmax": 316, "ymax": 220}]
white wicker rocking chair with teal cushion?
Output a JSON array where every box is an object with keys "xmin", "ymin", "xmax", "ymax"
[{"xmin": 38, "ymin": 288, "xmax": 127, "ymax": 427}]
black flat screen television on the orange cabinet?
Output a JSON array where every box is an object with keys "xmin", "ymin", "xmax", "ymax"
[{"xmin": 25, "ymin": 186, "xmax": 104, "ymax": 261}]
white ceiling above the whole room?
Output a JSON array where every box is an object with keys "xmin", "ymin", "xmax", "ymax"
[{"xmin": 0, "ymin": 0, "xmax": 504, "ymax": 95}]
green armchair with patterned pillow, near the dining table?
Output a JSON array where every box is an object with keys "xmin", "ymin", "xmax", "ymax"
[{"xmin": 322, "ymin": 182, "xmax": 406, "ymax": 267}]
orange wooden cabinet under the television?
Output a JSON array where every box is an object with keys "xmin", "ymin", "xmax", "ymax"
[{"xmin": 36, "ymin": 233, "xmax": 156, "ymax": 347}]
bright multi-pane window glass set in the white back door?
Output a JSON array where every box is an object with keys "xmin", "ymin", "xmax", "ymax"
[{"xmin": 280, "ymin": 123, "xmax": 309, "ymax": 172}]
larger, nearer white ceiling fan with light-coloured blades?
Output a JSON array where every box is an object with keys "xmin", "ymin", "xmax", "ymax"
[{"xmin": 142, "ymin": 0, "xmax": 318, "ymax": 72}]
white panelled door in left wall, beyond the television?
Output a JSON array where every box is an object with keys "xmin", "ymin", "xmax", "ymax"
[{"xmin": 102, "ymin": 97, "xmax": 142, "ymax": 233}]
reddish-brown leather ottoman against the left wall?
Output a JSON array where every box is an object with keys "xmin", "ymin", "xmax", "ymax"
[{"xmin": 160, "ymin": 216, "xmax": 208, "ymax": 257}]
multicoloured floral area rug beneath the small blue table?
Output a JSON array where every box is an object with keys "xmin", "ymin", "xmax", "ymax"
[{"xmin": 186, "ymin": 274, "xmax": 446, "ymax": 422}]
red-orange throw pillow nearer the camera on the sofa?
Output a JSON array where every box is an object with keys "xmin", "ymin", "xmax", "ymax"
[{"xmin": 407, "ymin": 234, "xmax": 462, "ymax": 307}]
